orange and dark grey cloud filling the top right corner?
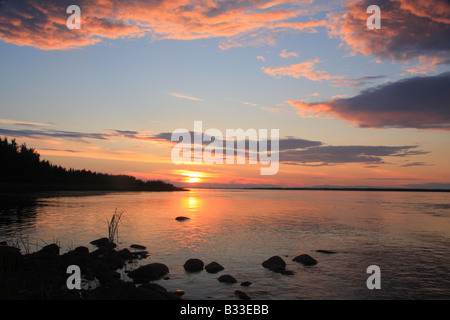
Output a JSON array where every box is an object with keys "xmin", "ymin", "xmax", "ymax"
[{"xmin": 328, "ymin": 0, "xmax": 450, "ymax": 64}]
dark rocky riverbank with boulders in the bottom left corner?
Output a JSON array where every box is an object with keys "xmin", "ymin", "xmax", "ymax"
[{"xmin": 0, "ymin": 238, "xmax": 185, "ymax": 300}]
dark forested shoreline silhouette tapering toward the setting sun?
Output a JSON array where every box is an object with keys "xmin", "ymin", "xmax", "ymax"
[{"xmin": 0, "ymin": 137, "xmax": 184, "ymax": 191}]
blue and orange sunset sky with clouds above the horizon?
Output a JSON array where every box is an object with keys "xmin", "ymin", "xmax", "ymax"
[{"xmin": 0, "ymin": 0, "xmax": 450, "ymax": 188}]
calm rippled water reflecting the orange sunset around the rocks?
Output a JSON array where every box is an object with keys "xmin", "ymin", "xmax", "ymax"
[{"xmin": 0, "ymin": 190, "xmax": 450, "ymax": 300}]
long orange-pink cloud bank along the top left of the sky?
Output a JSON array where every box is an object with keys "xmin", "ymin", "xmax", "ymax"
[{"xmin": 0, "ymin": 0, "xmax": 326, "ymax": 50}]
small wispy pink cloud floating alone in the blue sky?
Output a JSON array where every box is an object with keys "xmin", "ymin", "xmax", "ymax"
[{"xmin": 262, "ymin": 58, "xmax": 342, "ymax": 81}]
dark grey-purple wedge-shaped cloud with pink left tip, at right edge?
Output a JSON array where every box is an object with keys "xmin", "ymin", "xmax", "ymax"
[{"xmin": 287, "ymin": 72, "xmax": 450, "ymax": 130}]
